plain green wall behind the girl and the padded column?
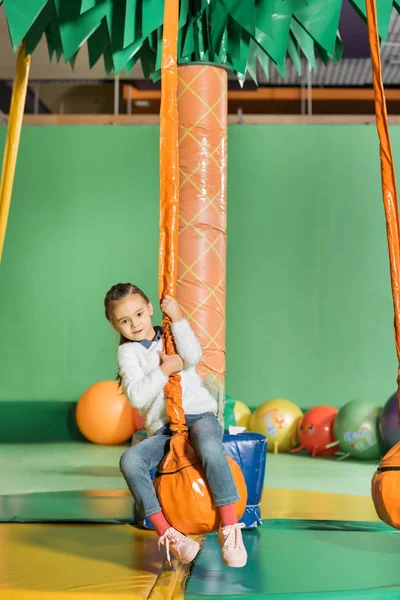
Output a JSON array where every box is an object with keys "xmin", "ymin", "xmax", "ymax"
[{"xmin": 0, "ymin": 125, "xmax": 400, "ymax": 407}]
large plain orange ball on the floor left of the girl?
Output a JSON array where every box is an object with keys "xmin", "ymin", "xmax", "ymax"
[{"xmin": 76, "ymin": 381, "xmax": 139, "ymax": 446}]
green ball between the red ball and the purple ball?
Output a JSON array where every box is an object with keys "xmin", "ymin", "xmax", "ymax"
[{"xmin": 334, "ymin": 400, "xmax": 383, "ymax": 460}]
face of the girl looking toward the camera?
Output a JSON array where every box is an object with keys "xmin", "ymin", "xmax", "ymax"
[{"xmin": 112, "ymin": 294, "xmax": 155, "ymax": 342}]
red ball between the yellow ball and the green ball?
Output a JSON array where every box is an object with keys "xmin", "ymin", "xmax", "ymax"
[{"xmin": 296, "ymin": 406, "xmax": 339, "ymax": 456}]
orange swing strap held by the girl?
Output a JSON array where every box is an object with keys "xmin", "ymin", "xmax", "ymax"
[{"xmin": 158, "ymin": 0, "xmax": 187, "ymax": 432}]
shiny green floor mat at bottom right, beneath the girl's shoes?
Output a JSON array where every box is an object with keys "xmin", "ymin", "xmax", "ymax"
[{"xmin": 185, "ymin": 520, "xmax": 400, "ymax": 600}]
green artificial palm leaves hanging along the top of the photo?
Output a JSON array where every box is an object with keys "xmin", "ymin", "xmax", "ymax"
[{"xmin": 0, "ymin": 0, "xmax": 400, "ymax": 82}]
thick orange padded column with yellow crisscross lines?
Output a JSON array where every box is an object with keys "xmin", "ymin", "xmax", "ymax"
[{"xmin": 177, "ymin": 65, "xmax": 227, "ymax": 419}]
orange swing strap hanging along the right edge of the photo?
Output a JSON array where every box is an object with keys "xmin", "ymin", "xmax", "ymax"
[{"xmin": 366, "ymin": 0, "xmax": 400, "ymax": 414}]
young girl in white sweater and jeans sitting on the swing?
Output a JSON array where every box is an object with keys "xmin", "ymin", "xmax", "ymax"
[{"xmin": 104, "ymin": 283, "xmax": 247, "ymax": 567}]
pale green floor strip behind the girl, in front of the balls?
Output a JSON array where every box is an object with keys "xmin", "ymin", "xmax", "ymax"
[{"xmin": 0, "ymin": 442, "xmax": 378, "ymax": 496}]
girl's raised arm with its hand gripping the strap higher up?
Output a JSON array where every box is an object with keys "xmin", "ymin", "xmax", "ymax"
[{"xmin": 161, "ymin": 296, "xmax": 202, "ymax": 369}]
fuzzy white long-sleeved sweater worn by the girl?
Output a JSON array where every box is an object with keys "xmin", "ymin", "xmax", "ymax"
[{"xmin": 118, "ymin": 319, "xmax": 218, "ymax": 436}]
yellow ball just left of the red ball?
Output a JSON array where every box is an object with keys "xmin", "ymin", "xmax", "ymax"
[{"xmin": 249, "ymin": 398, "xmax": 303, "ymax": 453}]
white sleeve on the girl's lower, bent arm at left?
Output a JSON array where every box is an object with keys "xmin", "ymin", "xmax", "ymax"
[{"xmin": 118, "ymin": 344, "xmax": 168, "ymax": 410}]
